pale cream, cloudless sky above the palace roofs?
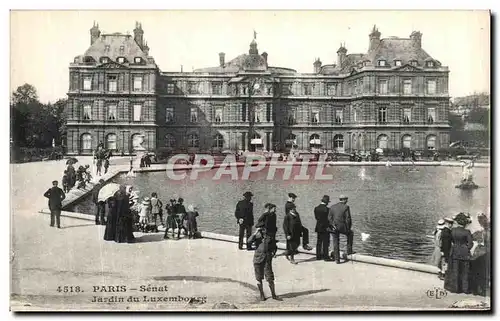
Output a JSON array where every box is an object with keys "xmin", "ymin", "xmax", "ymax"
[{"xmin": 10, "ymin": 10, "xmax": 490, "ymax": 103}]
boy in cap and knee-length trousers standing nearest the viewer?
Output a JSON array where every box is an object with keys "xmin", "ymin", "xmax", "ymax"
[{"xmin": 253, "ymin": 203, "xmax": 281, "ymax": 301}]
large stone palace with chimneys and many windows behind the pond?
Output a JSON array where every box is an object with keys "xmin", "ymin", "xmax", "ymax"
[{"xmin": 67, "ymin": 23, "xmax": 450, "ymax": 154}]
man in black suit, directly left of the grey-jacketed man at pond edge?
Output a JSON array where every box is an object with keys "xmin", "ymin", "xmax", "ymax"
[{"xmin": 314, "ymin": 195, "xmax": 331, "ymax": 261}]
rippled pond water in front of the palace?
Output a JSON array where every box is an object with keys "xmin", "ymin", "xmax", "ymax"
[{"xmin": 72, "ymin": 166, "xmax": 490, "ymax": 263}]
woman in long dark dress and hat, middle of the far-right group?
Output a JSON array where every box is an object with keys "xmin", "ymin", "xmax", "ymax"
[{"xmin": 444, "ymin": 213, "xmax": 473, "ymax": 293}]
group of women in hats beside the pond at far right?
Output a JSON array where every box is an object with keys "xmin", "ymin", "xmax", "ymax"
[{"xmin": 432, "ymin": 212, "xmax": 491, "ymax": 296}]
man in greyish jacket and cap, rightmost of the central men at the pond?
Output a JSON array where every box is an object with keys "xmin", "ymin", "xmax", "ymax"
[{"xmin": 328, "ymin": 195, "xmax": 353, "ymax": 264}]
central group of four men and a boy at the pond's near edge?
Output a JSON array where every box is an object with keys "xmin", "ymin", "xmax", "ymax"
[{"xmin": 235, "ymin": 192, "xmax": 354, "ymax": 300}]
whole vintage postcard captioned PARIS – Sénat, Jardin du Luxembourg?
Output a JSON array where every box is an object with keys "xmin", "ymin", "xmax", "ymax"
[{"xmin": 10, "ymin": 10, "xmax": 492, "ymax": 311}]
